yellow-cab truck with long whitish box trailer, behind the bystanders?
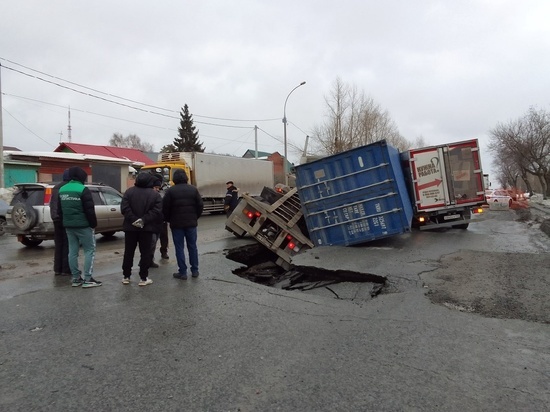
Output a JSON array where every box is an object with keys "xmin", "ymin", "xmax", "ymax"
[{"xmin": 141, "ymin": 152, "xmax": 274, "ymax": 213}]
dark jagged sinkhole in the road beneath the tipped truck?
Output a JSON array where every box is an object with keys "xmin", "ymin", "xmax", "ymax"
[{"xmin": 225, "ymin": 244, "xmax": 387, "ymax": 297}]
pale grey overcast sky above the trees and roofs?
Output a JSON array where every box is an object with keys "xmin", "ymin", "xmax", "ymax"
[{"xmin": 0, "ymin": 0, "xmax": 550, "ymax": 177}]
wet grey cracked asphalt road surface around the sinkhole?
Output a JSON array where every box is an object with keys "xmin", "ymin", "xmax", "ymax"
[{"xmin": 0, "ymin": 211, "xmax": 550, "ymax": 411}]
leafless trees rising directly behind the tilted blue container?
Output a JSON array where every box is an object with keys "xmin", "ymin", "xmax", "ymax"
[{"xmin": 312, "ymin": 78, "xmax": 411, "ymax": 155}]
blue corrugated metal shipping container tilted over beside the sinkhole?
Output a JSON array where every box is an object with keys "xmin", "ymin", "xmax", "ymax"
[{"xmin": 296, "ymin": 140, "xmax": 413, "ymax": 246}]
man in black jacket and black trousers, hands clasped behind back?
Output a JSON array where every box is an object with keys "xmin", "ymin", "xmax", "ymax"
[{"xmin": 120, "ymin": 172, "xmax": 162, "ymax": 286}]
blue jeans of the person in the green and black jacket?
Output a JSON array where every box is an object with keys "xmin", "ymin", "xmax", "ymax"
[{"xmin": 65, "ymin": 227, "xmax": 95, "ymax": 280}]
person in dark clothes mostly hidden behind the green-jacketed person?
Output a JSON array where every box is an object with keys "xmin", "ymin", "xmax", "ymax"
[{"xmin": 50, "ymin": 169, "xmax": 71, "ymax": 276}]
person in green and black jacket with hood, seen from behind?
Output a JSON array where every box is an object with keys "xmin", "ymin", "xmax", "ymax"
[{"xmin": 58, "ymin": 166, "xmax": 101, "ymax": 288}]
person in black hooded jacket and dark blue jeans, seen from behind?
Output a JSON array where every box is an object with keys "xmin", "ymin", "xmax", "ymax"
[{"xmin": 162, "ymin": 169, "xmax": 204, "ymax": 280}]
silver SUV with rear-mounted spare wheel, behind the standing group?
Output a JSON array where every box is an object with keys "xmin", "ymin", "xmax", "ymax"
[{"xmin": 5, "ymin": 183, "xmax": 124, "ymax": 247}]
